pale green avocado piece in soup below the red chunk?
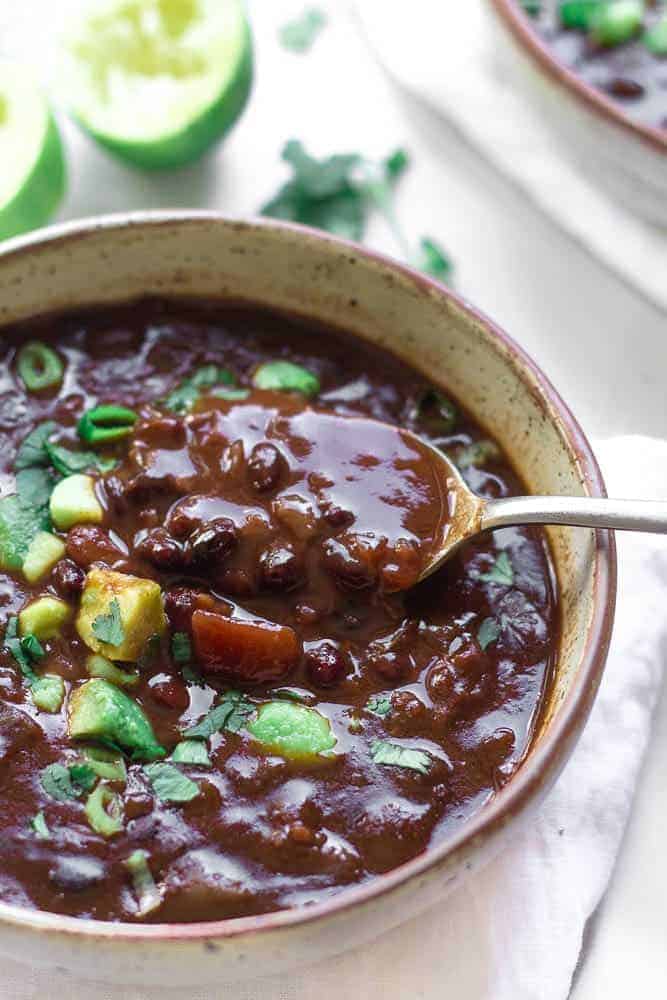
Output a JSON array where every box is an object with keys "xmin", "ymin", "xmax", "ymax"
[{"xmin": 248, "ymin": 701, "xmax": 336, "ymax": 757}]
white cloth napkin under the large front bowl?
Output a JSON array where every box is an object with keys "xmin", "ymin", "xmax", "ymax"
[{"xmin": 5, "ymin": 437, "xmax": 667, "ymax": 1000}]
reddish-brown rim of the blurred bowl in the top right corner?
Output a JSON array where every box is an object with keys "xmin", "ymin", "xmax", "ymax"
[{"xmin": 489, "ymin": 0, "xmax": 667, "ymax": 154}]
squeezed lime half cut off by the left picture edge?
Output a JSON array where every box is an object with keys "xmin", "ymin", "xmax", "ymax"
[{"xmin": 0, "ymin": 62, "xmax": 65, "ymax": 239}]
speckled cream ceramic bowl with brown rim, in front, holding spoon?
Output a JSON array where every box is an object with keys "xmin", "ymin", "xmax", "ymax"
[{"xmin": 0, "ymin": 213, "xmax": 615, "ymax": 989}]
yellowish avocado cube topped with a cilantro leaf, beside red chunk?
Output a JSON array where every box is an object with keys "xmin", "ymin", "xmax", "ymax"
[{"xmin": 76, "ymin": 569, "xmax": 167, "ymax": 662}]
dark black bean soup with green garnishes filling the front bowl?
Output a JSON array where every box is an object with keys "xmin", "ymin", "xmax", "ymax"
[{"xmin": 0, "ymin": 301, "xmax": 559, "ymax": 922}]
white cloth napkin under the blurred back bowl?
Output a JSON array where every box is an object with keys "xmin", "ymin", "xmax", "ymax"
[{"xmin": 354, "ymin": 0, "xmax": 667, "ymax": 308}]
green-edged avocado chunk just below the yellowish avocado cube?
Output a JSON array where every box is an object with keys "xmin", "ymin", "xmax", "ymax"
[{"xmin": 68, "ymin": 677, "xmax": 166, "ymax": 760}]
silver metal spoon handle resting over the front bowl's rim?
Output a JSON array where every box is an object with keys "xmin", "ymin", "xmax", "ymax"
[{"xmin": 480, "ymin": 497, "xmax": 667, "ymax": 534}]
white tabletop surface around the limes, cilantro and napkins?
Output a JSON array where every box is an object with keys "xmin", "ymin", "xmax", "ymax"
[{"xmin": 0, "ymin": 0, "xmax": 667, "ymax": 1000}]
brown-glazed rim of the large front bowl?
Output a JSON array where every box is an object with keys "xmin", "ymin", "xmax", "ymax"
[{"xmin": 0, "ymin": 210, "xmax": 616, "ymax": 943}]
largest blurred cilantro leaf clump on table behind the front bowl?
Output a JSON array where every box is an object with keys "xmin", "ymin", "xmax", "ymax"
[{"xmin": 261, "ymin": 139, "xmax": 407, "ymax": 240}]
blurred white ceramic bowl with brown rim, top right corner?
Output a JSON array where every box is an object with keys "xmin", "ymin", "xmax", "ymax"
[{"xmin": 485, "ymin": 0, "xmax": 667, "ymax": 226}]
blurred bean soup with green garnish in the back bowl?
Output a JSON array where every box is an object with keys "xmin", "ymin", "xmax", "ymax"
[{"xmin": 517, "ymin": 0, "xmax": 667, "ymax": 132}]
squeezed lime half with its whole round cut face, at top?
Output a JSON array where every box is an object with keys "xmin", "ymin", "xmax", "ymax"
[{"xmin": 63, "ymin": 0, "xmax": 252, "ymax": 170}]
